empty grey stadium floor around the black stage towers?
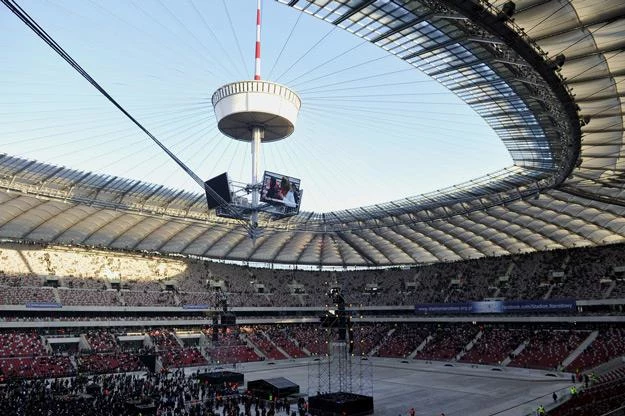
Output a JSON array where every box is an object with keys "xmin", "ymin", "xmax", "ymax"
[{"xmin": 184, "ymin": 359, "xmax": 570, "ymax": 416}]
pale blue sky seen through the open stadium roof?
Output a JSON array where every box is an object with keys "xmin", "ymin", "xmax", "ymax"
[{"xmin": 0, "ymin": 0, "xmax": 512, "ymax": 212}]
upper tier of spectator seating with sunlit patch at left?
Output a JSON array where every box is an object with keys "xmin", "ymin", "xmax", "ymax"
[{"xmin": 0, "ymin": 240, "xmax": 625, "ymax": 307}]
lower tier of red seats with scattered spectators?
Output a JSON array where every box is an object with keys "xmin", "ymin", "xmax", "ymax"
[{"xmin": 0, "ymin": 322, "xmax": 625, "ymax": 378}]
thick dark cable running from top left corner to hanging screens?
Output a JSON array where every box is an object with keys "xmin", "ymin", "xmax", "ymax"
[{"xmin": 1, "ymin": 0, "xmax": 249, "ymax": 231}]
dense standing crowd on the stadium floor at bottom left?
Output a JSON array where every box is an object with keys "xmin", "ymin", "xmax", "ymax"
[{"xmin": 0, "ymin": 371, "xmax": 304, "ymax": 416}]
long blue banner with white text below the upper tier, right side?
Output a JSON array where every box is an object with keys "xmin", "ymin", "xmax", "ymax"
[{"xmin": 415, "ymin": 299, "xmax": 577, "ymax": 315}]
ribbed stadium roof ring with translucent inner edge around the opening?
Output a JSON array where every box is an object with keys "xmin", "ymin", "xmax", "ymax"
[{"xmin": 0, "ymin": 0, "xmax": 625, "ymax": 266}]
